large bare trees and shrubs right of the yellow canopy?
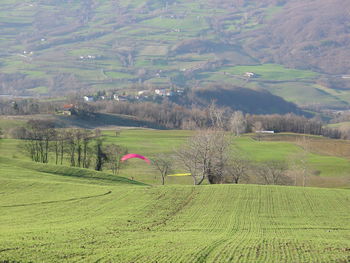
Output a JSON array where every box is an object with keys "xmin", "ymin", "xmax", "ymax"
[{"xmin": 171, "ymin": 105, "xmax": 307, "ymax": 185}]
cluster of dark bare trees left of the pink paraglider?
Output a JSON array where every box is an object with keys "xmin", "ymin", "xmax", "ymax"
[{"xmin": 16, "ymin": 120, "xmax": 127, "ymax": 173}]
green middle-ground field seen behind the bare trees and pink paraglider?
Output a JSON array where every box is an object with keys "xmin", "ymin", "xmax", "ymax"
[{"xmin": 0, "ymin": 129, "xmax": 350, "ymax": 187}]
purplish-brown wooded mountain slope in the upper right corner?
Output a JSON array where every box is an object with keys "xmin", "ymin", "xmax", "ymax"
[{"xmin": 246, "ymin": 0, "xmax": 350, "ymax": 74}]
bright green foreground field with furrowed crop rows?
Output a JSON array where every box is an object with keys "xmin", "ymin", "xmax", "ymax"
[{"xmin": 0, "ymin": 158, "xmax": 350, "ymax": 262}]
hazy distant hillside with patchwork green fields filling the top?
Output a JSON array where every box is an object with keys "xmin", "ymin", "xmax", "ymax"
[{"xmin": 0, "ymin": 0, "xmax": 350, "ymax": 107}]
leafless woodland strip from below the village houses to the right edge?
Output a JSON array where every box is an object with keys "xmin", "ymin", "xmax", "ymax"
[{"xmin": 98, "ymin": 100, "xmax": 342, "ymax": 138}]
